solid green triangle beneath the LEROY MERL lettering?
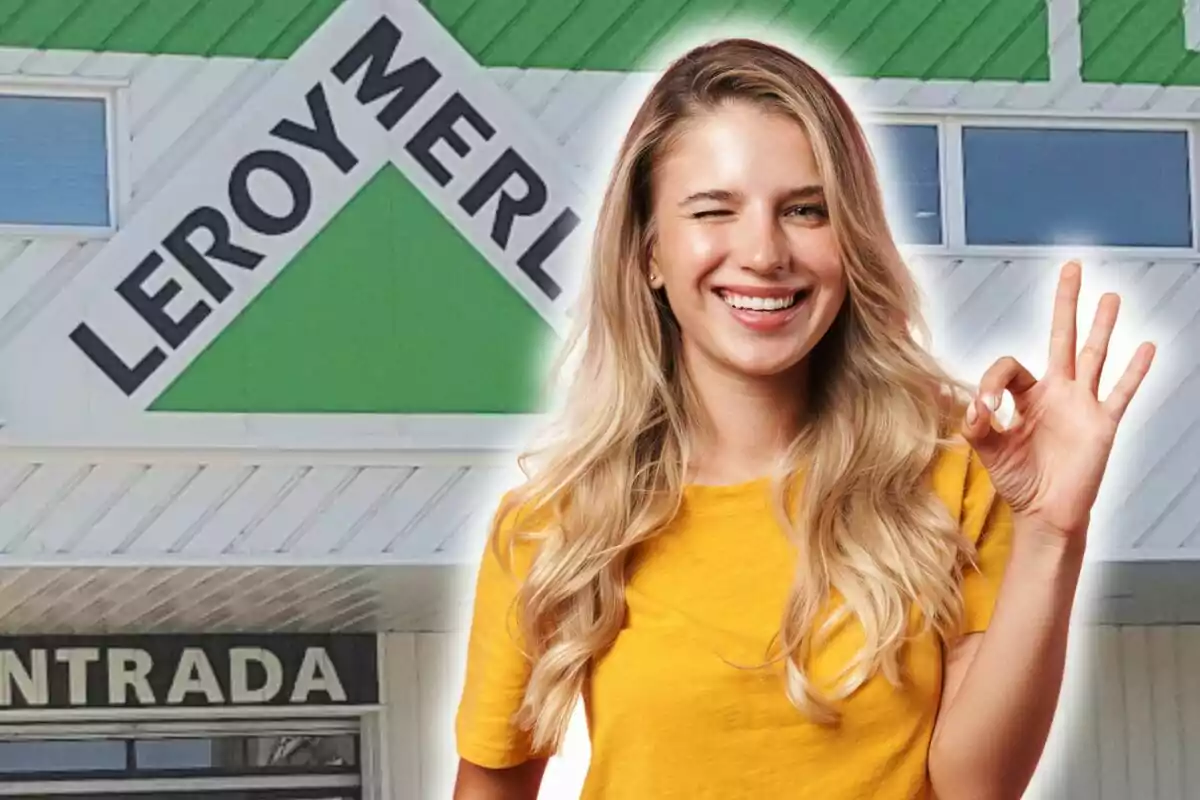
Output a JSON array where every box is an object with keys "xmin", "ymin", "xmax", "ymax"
[{"xmin": 149, "ymin": 164, "xmax": 554, "ymax": 414}]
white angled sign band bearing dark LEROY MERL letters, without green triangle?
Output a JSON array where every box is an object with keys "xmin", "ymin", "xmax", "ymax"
[{"xmin": 0, "ymin": 0, "xmax": 582, "ymax": 425}]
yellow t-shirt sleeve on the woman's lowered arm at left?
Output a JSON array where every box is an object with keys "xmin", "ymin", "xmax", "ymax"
[{"xmin": 455, "ymin": 494, "xmax": 549, "ymax": 769}]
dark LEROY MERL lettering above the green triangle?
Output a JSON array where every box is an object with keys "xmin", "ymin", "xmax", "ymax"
[{"xmin": 70, "ymin": 17, "xmax": 580, "ymax": 395}]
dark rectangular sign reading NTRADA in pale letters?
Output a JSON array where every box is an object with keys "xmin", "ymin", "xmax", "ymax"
[{"xmin": 0, "ymin": 634, "xmax": 379, "ymax": 709}]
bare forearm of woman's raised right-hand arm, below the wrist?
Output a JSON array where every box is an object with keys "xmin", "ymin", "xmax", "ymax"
[{"xmin": 929, "ymin": 517, "xmax": 1084, "ymax": 800}]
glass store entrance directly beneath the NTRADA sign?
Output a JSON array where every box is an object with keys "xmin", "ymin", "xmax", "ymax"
[{"xmin": 0, "ymin": 718, "xmax": 362, "ymax": 800}]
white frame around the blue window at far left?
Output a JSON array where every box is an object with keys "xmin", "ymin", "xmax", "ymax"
[{"xmin": 0, "ymin": 76, "xmax": 128, "ymax": 239}]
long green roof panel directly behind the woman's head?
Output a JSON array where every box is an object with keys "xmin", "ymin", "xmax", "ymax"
[{"xmin": 428, "ymin": 0, "xmax": 1049, "ymax": 80}]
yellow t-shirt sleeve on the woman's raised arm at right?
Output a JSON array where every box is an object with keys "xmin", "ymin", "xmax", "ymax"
[{"xmin": 959, "ymin": 451, "xmax": 1013, "ymax": 633}]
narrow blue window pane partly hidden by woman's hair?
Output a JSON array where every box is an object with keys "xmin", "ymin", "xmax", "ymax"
[{"xmin": 866, "ymin": 125, "xmax": 942, "ymax": 245}]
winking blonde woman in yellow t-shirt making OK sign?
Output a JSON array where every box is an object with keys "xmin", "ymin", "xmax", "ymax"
[{"xmin": 456, "ymin": 40, "xmax": 1153, "ymax": 800}]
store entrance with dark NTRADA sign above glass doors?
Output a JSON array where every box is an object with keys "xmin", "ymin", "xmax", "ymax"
[{"xmin": 0, "ymin": 634, "xmax": 379, "ymax": 800}]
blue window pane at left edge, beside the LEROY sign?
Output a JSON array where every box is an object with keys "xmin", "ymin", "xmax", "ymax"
[{"xmin": 0, "ymin": 95, "xmax": 109, "ymax": 227}]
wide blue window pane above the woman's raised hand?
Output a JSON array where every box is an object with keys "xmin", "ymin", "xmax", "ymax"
[{"xmin": 962, "ymin": 127, "xmax": 1192, "ymax": 247}]
